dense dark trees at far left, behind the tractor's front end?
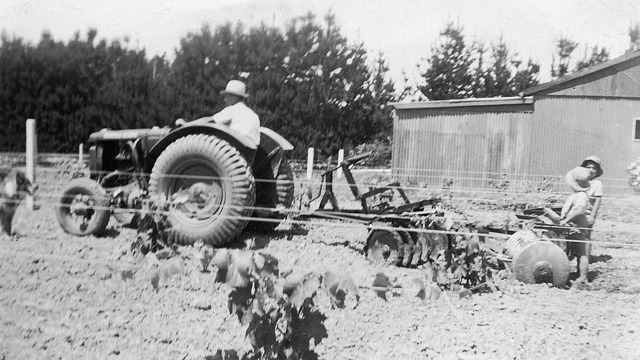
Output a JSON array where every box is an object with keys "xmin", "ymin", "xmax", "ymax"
[{"xmin": 0, "ymin": 29, "xmax": 166, "ymax": 152}]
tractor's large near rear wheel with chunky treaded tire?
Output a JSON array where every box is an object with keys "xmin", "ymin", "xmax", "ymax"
[{"xmin": 149, "ymin": 134, "xmax": 256, "ymax": 246}]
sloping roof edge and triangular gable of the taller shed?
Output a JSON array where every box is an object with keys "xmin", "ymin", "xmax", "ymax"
[{"xmin": 522, "ymin": 50, "xmax": 640, "ymax": 96}]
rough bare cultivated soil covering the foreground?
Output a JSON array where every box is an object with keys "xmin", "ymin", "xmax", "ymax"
[{"xmin": 0, "ymin": 164, "xmax": 640, "ymax": 359}]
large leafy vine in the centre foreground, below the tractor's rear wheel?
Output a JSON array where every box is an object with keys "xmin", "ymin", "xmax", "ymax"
[{"xmin": 211, "ymin": 249, "xmax": 332, "ymax": 359}]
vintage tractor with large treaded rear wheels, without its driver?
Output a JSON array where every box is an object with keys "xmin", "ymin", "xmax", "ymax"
[{"xmin": 57, "ymin": 122, "xmax": 294, "ymax": 246}]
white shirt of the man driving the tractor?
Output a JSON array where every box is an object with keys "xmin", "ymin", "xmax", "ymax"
[{"xmin": 212, "ymin": 102, "xmax": 260, "ymax": 149}]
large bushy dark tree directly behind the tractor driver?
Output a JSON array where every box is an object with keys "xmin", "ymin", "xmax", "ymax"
[{"xmin": 172, "ymin": 14, "xmax": 395, "ymax": 156}]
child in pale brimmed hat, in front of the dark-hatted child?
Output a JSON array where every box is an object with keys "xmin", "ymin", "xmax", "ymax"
[{"xmin": 559, "ymin": 166, "xmax": 591, "ymax": 284}]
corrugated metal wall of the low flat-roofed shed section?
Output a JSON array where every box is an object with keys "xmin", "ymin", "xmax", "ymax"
[{"xmin": 393, "ymin": 105, "xmax": 531, "ymax": 187}]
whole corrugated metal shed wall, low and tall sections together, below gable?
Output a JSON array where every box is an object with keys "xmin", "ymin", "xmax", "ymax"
[{"xmin": 392, "ymin": 97, "xmax": 640, "ymax": 192}]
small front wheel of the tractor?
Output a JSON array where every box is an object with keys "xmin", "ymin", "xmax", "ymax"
[{"xmin": 56, "ymin": 178, "xmax": 111, "ymax": 236}]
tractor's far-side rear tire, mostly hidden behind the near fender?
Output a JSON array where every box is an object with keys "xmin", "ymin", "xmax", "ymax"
[{"xmin": 247, "ymin": 158, "xmax": 295, "ymax": 233}]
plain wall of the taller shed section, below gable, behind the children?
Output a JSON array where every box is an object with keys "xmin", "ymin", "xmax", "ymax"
[{"xmin": 528, "ymin": 97, "xmax": 640, "ymax": 190}]
